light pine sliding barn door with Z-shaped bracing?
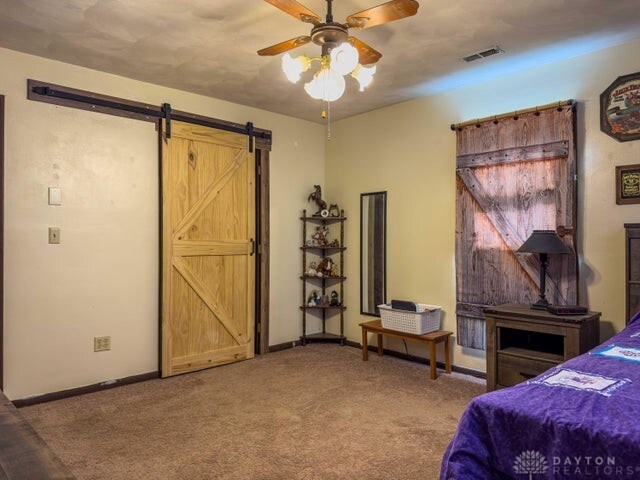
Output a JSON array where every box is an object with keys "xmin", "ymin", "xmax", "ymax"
[{"xmin": 162, "ymin": 122, "xmax": 256, "ymax": 377}]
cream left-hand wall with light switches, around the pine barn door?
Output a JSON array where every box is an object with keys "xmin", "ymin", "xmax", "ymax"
[{"xmin": 0, "ymin": 49, "xmax": 324, "ymax": 399}]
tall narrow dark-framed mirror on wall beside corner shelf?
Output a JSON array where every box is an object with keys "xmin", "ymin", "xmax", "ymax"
[{"xmin": 360, "ymin": 192, "xmax": 387, "ymax": 317}]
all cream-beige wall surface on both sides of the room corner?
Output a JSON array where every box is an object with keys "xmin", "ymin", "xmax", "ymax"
[{"xmin": 5, "ymin": 37, "xmax": 640, "ymax": 399}]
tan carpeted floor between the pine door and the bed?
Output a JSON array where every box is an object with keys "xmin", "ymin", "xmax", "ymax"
[{"xmin": 21, "ymin": 344, "xmax": 484, "ymax": 480}]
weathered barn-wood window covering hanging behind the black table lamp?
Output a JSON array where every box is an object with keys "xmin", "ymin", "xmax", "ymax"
[{"xmin": 456, "ymin": 106, "xmax": 578, "ymax": 349}]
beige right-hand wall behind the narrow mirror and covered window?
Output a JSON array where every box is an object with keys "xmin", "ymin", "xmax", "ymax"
[{"xmin": 325, "ymin": 41, "xmax": 640, "ymax": 371}]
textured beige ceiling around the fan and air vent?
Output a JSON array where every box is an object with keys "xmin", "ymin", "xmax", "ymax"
[{"xmin": 0, "ymin": 0, "xmax": 640, "ymax": 121}]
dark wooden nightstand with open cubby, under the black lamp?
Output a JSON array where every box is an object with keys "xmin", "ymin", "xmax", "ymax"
[{"xmin": 485, "ymin": 305, "xmax": 600, "ymax": 392}]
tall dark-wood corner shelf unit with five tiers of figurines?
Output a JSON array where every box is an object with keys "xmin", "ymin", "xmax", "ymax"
[{"xmin": 300, "ymin": 210, "xmax": 347, "ymax": 345}]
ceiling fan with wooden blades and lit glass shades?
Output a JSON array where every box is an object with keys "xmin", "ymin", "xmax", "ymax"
[{"xmin": 258, "ymin": 0, "xmax": 419, "ymax": 102}]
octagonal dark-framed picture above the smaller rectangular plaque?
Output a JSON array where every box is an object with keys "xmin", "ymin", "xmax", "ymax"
[{"xmin": 600, "ymin": 72, "xmax": 640, "ymax": 142}]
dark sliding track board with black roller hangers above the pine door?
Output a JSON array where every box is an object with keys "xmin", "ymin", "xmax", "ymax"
[{"xmin": 27, "ymin": 80, "xmax": 271, "ymax": 152}]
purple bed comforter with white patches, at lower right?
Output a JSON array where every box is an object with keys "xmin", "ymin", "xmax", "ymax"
[{"xmin": 440, "ymin": 314, "xmax": 640, "ymax": 480}]
